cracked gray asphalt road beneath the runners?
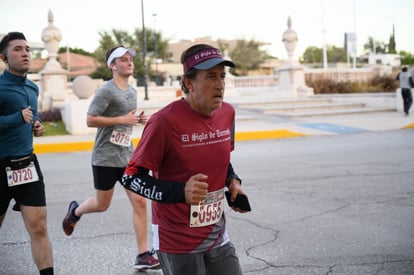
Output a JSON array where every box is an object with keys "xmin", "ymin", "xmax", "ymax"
[{"xmin": 0, "ymin": 129, "xmax": 414, "ymax": 275}]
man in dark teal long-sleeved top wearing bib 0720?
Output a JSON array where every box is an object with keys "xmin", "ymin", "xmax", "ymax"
[{"xmin": 0, "ymin": 32, "xmax": 53, "ymax": 275}]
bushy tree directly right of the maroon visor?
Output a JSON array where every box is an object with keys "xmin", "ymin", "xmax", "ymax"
[{"xmin": 229, "ymin": 40, "xmax": 268, "ymax": 75}]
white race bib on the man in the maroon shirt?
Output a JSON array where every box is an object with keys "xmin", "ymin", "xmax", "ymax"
[{"xmin": 190, "ymin": 188, "xmax": 224, "ymax": 227}]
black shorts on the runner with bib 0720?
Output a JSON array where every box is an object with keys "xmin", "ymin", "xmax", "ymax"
[{"xmin": 0, "ymin": 154, "xmax": 46, "ymax": 215}]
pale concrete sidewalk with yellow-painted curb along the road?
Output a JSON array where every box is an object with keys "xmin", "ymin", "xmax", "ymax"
[{"xmin": 34, "ymin": 109, "xmax": 414, "ymax": 154}]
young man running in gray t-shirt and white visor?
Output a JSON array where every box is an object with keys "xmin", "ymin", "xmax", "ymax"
[{"xmin": 63, "ymin": 46, "xmax": 160, "ymax": 270}]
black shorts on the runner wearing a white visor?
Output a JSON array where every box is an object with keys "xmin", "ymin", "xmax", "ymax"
[{"xmin": 92, "ymin": 165, "xmax": 125, "ymax": 191}]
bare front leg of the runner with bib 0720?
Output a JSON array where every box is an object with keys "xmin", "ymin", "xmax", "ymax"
[{"xmin": 20, "ymin": 205, "xmax": 53, "ymax": 270}]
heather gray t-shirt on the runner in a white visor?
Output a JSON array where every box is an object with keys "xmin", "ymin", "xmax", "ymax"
[{"xmin": 88, "ymin": 79, "xmax": 137, "ymax": 168}]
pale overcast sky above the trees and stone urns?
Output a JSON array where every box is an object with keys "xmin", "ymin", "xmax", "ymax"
[{"xmin": 0, "ymin": 0, "xmax": 414, "ymax": 59}]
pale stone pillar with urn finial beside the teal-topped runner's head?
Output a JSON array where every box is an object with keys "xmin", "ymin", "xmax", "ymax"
[{"xmin": 40, "ymin": 10, "xmax": 69, "ymax": 111}]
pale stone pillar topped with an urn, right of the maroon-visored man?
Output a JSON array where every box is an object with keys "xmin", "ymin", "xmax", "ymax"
[{"xmin": 277, "ymin": 17, "xmax": 313, "ymax": 98}]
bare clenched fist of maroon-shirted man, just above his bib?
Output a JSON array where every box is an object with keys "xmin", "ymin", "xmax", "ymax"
[{"xmin": 184, "ymin": 174, "xmax": 208, "ymax": 204}]
